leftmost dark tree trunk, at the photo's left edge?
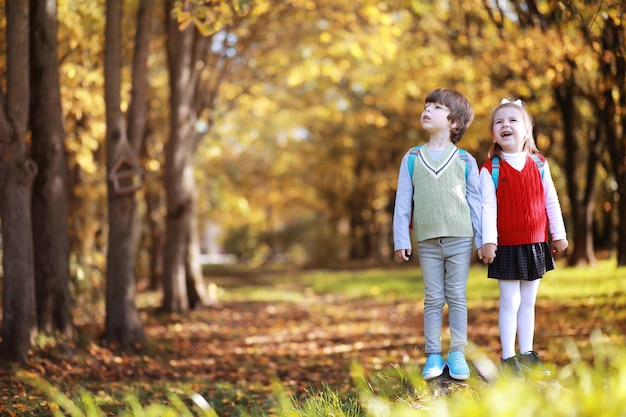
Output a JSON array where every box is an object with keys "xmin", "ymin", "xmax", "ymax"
[{"xmin": 0, "ymin": 0, "xmax": 37, "ymax": 361}]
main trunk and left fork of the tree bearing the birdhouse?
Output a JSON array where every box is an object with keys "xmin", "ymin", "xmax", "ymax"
[{"xmin": 104, "ymin": 0, "xmax": 145, "ymax": 349}]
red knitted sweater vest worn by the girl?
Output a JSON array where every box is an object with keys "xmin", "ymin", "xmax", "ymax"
[{"xmin": 485, "ymin": 156, "xmax": 548, "ymax": 246}]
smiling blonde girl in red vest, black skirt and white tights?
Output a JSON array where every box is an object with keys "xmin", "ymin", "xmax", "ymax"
[{"xmin": 479, "ymin": 99, "xmax": 568, "ymax": 380}]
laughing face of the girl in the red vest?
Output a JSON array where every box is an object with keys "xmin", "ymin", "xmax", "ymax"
[{"xmin": 491, "ymin": 106, "xmax": 529, "ymax": 153}]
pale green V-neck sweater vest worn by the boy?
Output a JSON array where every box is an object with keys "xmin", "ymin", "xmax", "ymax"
[{"xmin": 413, "ymin": 145, "xmax": 474, "ymax": 242}]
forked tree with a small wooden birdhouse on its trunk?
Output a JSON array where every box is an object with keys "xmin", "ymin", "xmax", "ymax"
[{"xmin": 104, "ymin": 0, "xmax": 152, "ymax": 349}]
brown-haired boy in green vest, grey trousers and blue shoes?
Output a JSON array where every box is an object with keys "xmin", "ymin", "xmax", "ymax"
[{"xmin": 393, "ymin": 88, "xmax": 482, "ymax": 380}]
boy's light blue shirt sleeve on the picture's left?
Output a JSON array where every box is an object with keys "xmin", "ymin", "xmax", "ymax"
[{"xmin": 393, "ymin": 152, "xmax": 413, "ymax": 251}]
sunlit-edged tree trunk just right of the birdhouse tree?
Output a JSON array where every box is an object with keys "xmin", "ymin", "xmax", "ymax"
[{"xmin": 163, "ymin": 0, "xmax": 208, "ymax": 312}]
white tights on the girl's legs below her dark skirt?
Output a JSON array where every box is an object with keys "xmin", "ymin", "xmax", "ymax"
[{"xmin": 498, "ymin": 279, "xmax": 541, "ymax": 359}]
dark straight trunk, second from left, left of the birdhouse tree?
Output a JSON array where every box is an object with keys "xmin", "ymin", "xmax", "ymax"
[{"xmin": 30, "ymin": 0, "xmax": 73, "ymax": 337}]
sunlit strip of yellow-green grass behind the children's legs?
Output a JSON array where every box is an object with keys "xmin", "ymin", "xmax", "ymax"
[{"xmin": 207, "ymin": 260, "xmax": 626, "ymax": 302}]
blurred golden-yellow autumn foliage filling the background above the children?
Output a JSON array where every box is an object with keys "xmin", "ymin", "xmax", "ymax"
[{"xmin": 45, "ymin": 0, "xmax": 621, "ymax": 264}]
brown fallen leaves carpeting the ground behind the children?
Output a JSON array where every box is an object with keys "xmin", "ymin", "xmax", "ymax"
[{"xmin": 0, "ymin": 299, "xmax": 626, "ymax": 415}]
